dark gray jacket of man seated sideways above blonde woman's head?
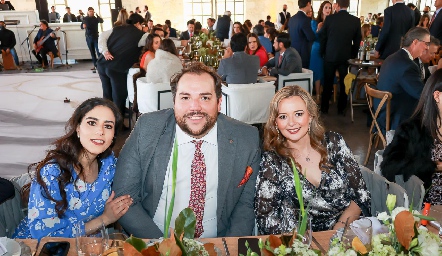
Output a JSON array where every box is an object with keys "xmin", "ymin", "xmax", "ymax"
[{"xmin": 264, "ymin": 47, "xmax": 302, "ymax": 76}]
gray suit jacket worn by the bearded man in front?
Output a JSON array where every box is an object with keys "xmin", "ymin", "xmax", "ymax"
[{"xmin": 112, "ymin": 109, "xmax": 261, "ymax": 238}]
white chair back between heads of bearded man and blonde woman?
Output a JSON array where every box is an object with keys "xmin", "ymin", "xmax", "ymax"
[{"xmin": 221, "ymin": 82, "xmax": 275, "ymax": 124}]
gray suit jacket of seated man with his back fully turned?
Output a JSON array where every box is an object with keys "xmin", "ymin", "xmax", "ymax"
[{"xmin": 218, "ymin": 52, "xmax": 259, "ymax": 84}]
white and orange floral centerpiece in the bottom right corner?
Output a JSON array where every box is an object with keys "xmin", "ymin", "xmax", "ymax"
[{"xmin": 328, "ymin": 195, "xmax": 442, "ymax": 256}]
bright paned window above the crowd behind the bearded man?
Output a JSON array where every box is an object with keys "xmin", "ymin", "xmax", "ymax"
[{"xmin": 184, "ymin": 0, "xmax": 244, "ymax": 24}]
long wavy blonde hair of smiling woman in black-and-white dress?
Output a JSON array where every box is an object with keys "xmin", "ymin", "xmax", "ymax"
[{"xmin": 264, "ymin": 85, "xmax": 328, "ymax": 171}]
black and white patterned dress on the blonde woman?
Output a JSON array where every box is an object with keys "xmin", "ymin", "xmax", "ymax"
[{"xmin": 255, "ymin": 132, "xmax": 371, "ymax": 234}]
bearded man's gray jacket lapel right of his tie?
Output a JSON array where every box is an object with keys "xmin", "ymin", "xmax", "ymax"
[{"xmin": 216, "ymin": 114, "xmax": 237, "ymax": 223}]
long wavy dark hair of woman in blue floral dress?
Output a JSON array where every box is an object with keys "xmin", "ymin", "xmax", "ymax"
[{"xmin": 21, "ymin": 98, "xmax": 123, "ymax": 218}]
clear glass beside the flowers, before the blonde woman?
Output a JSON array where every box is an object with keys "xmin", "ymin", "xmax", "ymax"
[{"xmin": 342, "ymin": 216, "xmax": 373, "ymax": 251}]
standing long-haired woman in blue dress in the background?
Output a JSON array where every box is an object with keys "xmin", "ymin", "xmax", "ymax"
[{"xmin": 309, "ymin": 1, "xmax": 332, "ymax": 102}]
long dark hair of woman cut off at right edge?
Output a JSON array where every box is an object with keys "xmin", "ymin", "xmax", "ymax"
[{"xmin": 411, "ymin": 69, "xmax": 442, "ymax": 143}]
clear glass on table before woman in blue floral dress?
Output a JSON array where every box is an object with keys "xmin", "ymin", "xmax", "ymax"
[{"xmin": 75, "ymin": 223, "xmax": 108, "ymax": 256}]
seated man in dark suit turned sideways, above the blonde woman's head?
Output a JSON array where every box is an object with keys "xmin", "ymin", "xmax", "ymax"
[{"xmin": 262, "ymin": 32, "xmax": 302, "ymax": 77}]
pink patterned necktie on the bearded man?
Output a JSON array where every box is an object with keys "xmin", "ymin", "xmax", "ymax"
[{"xmin": 189, "ymin": 140, "xmax": 206, "ymax": 238}]
